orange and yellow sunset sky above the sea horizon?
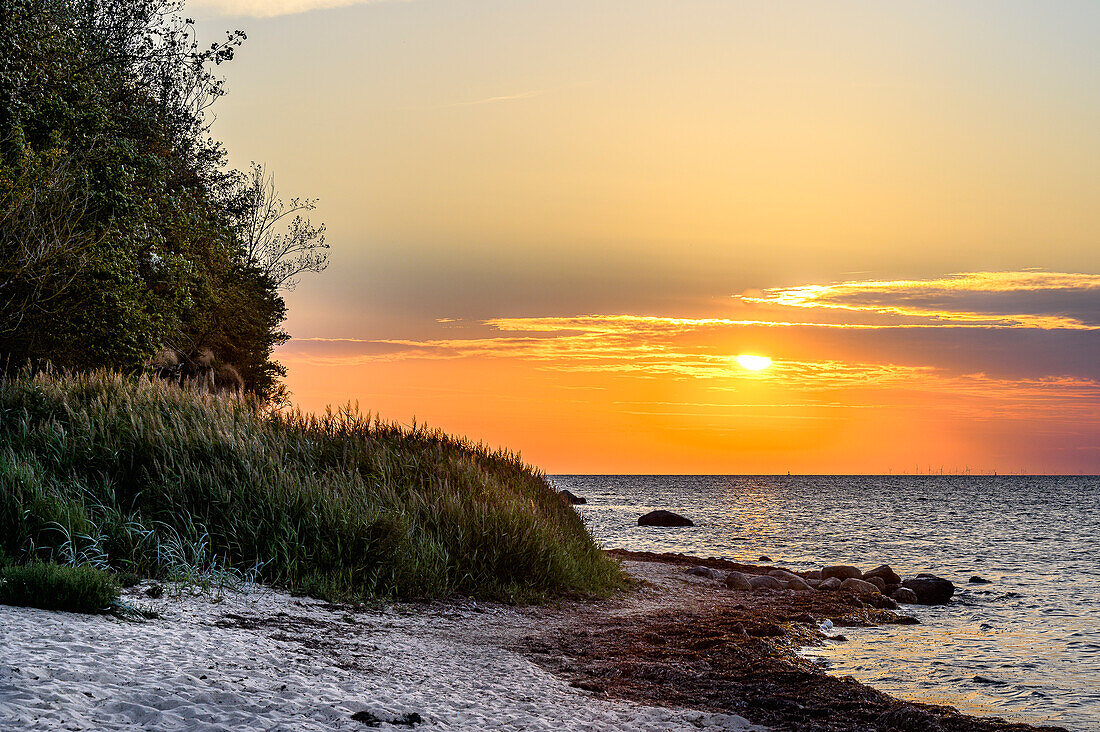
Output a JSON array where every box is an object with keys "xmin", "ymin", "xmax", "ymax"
[{"xmin": 188, "ymin": 0, "xmax": 1100, "ymax": 473}]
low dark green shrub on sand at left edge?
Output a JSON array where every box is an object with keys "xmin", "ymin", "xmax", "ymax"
[{"xmin": 0, "ymin": 561, "xmax": 119, "ymax": 613}]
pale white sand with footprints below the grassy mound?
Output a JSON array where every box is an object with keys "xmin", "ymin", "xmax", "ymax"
[{"xmin": 0, "ymin": 587, "xmax": 762, "ymax": 732}]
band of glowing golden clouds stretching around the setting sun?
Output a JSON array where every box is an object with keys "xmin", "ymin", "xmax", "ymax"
[{"xmin": 281, "ymin": 272, "xmax": 1100, "ymax": 402}]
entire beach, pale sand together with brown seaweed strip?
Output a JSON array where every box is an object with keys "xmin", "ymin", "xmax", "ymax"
[{"xmin": 0, "ymin": 551, "xmax": 1063, "ymax": 732}]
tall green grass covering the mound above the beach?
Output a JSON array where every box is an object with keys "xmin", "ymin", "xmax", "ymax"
[{"xmin": 0, "ymin": 372, "xmax": 623, "ymax": 601}]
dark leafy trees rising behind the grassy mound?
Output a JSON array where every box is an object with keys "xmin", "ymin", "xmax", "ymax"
[{"xmin": 0, "ymin": 0, "xmax": 325, "ymax": 397}]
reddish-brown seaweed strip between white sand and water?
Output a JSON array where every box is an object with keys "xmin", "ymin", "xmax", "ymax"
[{"xmin": 528, "ymin": 549, "xmax": 1065, "ymax": 732}]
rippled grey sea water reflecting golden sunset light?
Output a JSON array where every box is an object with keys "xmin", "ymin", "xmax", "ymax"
[{"xmin": 551, "ymin": 476, "xmax": 1100, "ymax": 731}]
